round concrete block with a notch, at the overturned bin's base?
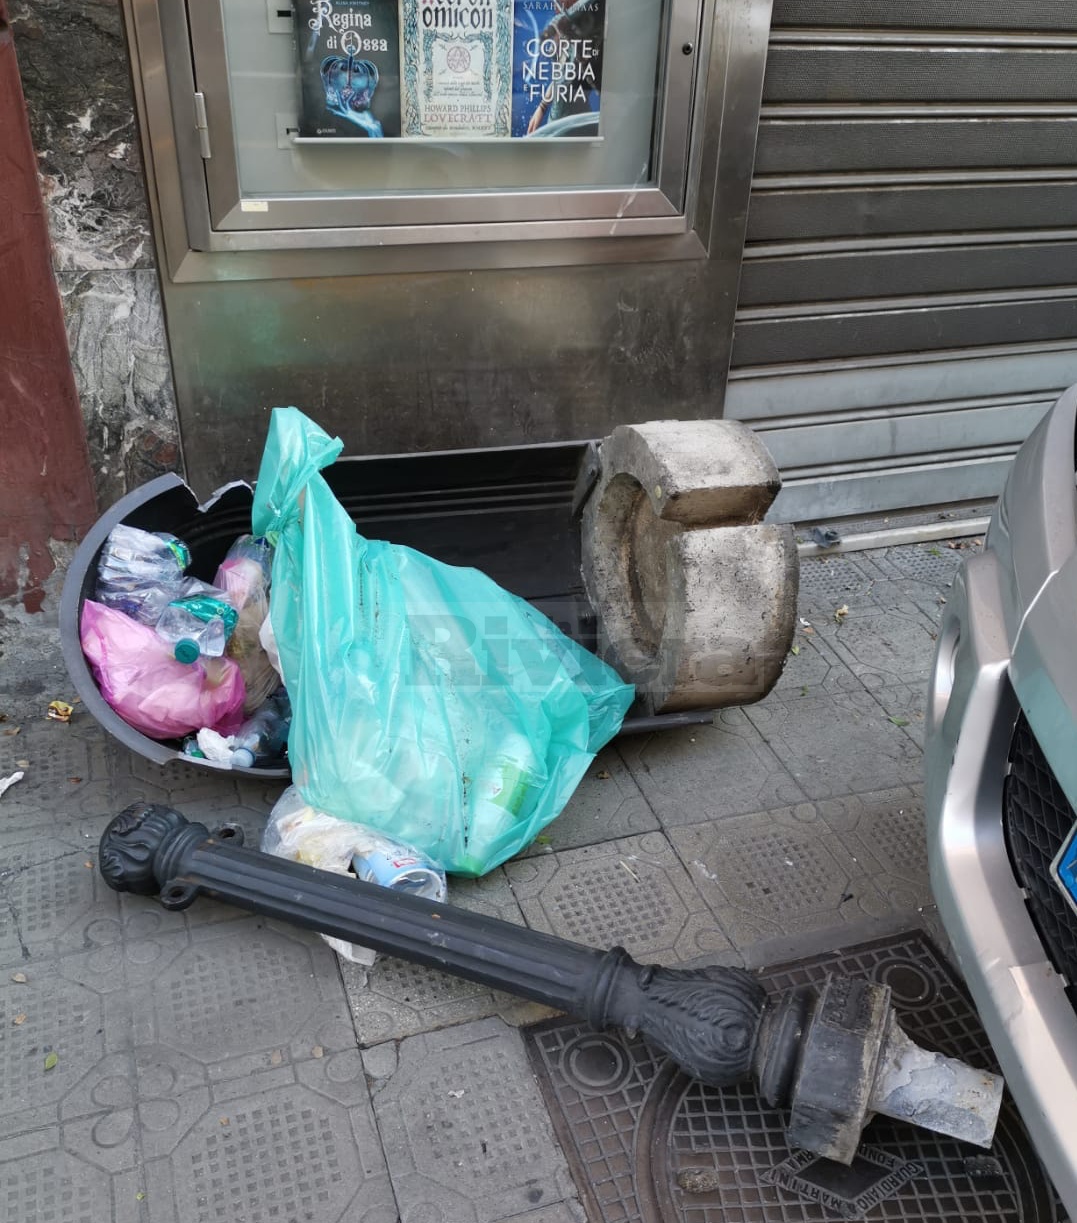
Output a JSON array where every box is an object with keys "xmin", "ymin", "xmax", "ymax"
[{"xmin": 582, "ymin": 421, "xmax": 799, "ymax": 713}]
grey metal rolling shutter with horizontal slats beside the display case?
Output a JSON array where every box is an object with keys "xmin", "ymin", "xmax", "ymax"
[{"xmin": 725, "ymin": 0, "xmax": 1077, "ymax": 521}]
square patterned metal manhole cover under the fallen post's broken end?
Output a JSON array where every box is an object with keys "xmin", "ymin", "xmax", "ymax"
[{"xmin": 527, "ymin": 932, "xmax": 1056, "ymax": 1223}]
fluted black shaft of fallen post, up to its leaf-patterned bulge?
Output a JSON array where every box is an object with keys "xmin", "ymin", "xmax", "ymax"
[{"xmin": 100, "ymin": 804, "xmax": 768, "ymax": 1086}]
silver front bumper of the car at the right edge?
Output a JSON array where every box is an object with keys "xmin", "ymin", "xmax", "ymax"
[{"xmin": 925, "ymin": 389, "xmax": 1077, "ymax": 1217}]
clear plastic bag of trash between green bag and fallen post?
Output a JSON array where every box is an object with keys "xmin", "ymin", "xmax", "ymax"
[{"xmin": 262, "ymin": 785, "xmax": 447, "ymax": 967}]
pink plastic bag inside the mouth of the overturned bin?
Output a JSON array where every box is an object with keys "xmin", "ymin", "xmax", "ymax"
[{"xmin": 81, "ymin": 599, "xmax": 246, "ymax": 739}]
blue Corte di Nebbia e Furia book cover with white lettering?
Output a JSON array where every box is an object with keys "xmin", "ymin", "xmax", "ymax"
[{"xmin": 512, "ymin": 0, "xmax": 606, "ymax": 139}]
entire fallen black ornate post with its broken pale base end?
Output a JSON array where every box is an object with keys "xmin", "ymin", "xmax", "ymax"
[{"xmin": 100, "ymin": 804, "xmax": 1002, "ymax": 1163}]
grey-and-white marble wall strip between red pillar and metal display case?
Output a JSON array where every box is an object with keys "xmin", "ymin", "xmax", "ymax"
[{"xmin": 10, "ymin": 0, "xmax": 181, "ymax": 506}]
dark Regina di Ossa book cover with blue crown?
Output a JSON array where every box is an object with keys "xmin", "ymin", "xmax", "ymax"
[{"xmin": 295, "ymin": 0, "xmax": 400, "ymax": 139}]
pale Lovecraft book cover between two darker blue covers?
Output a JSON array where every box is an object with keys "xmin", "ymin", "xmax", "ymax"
[{"xmin": 401, "ymin": 0, "xmax": 512, "ymax": 139}]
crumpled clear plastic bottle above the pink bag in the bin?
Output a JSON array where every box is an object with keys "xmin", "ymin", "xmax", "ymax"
[{"xmin": 95, "ymin": 522, "xmax": 191, "ymax": 624}]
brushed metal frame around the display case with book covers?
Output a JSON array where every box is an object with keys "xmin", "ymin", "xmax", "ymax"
[{"xmin": 123, "ymin": 0, "xmax": 770, "ymax": 283}]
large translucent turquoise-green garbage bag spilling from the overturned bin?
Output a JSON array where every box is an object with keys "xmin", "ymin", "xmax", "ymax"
[{"xmin": 253, "ymin": 407, "xmax": 633, "ymax": 876}]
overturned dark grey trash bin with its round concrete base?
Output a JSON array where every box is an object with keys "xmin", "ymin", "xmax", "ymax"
[{"xmin": 60, "ymin": 421, "xmax": 797, "ymax": 778}]
